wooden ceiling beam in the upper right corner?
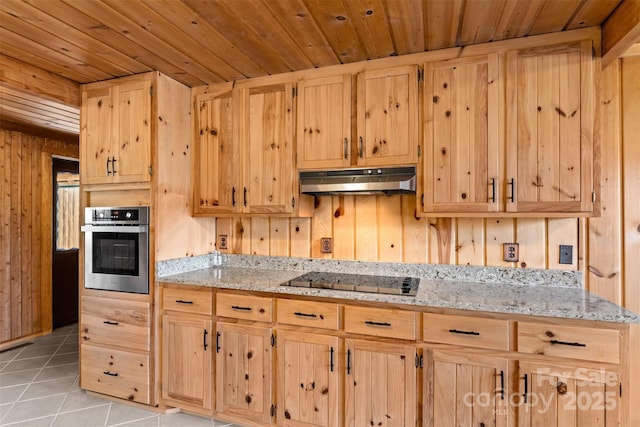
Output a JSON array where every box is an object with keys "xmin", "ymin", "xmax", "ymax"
[{"xmin": 602, "ymin": 0, "xmax": 640, "ymax": 68}]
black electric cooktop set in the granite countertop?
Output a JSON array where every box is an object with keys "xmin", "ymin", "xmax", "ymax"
[{"xmin": 281, "ymin": 271, "xmax": 420, "ymax": 296}]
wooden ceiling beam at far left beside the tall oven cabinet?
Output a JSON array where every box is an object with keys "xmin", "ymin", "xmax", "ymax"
[{"xmin": 0, "ymin": 55, "xmax": 82, "ymax": 107}]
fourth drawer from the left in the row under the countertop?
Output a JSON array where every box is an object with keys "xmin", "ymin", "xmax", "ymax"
[{"xmin": 344, "ymin": 306, "xmax": 416, "ymax": 340}]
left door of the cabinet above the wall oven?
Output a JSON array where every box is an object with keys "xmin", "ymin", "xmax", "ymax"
[{"xmin": 80, "ymin": 87, "xmax": 114, "ymax": 184}]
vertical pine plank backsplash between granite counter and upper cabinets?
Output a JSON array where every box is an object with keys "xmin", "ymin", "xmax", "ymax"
[{"xmin": 217, "ymin": 196, "xmax": 580, "ymax": 270}]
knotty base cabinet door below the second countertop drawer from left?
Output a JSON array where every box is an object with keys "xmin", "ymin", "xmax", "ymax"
[{"xmin": 216, "ymin": 322, "xmax": 273, "ymax": 423}]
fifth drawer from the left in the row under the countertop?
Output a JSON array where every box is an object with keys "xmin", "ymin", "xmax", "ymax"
[{"xmin": 423, "ymin": 313, "xmax": 509, "ymax": 350}]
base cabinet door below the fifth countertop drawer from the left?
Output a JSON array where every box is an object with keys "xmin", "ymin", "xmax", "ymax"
[{"xmin": 423, "ymin": 350, "xmax": 509, "ymax": 427}]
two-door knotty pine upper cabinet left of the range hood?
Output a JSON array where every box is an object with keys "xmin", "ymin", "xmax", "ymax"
[{"xmin": 193, "ymin": 83, "xmax": 313, "ymax": 216}]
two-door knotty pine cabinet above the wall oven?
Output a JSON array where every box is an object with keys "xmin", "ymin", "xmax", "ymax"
[{"xmin": 80, "ymin": 74, "xmax": 152, "ymax": 184}]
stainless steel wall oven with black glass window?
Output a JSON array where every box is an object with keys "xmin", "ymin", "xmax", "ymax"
[{"xmin": 82, "ymin": 206, "xmax": 149, "ymax": 294}]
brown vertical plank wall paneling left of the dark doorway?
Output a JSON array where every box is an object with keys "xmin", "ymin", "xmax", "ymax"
[{"xmin": 0, "ymin": 129, "xmax": 78, "ymax": 342}]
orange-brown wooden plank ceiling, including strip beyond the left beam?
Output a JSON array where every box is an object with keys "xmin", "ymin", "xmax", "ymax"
[{"xmin": 0, "ymin": 0, "xmax": 634, "ymax": 133}]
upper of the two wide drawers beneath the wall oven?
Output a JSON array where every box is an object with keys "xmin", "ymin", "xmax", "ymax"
[{"xmin": 80, "ymin": 296, "xmax": 151, "ymax": 351}]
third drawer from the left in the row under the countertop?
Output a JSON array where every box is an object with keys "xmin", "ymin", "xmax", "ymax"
[{"xmin": 278, "ymin": 299, "xmax": 340, "ymax": 330}]
